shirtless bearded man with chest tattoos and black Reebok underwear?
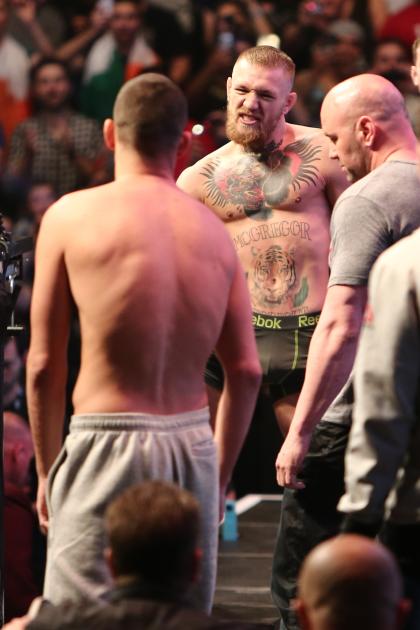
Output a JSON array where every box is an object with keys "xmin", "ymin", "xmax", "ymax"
[{"xmin": 178, "ymin": 46, "xmax": 348, "ymax": 433}]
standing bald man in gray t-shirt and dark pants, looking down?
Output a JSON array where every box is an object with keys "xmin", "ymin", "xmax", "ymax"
[{"xmin": 273, "ymin": 74, "xmax": 420, "ymax": 629}]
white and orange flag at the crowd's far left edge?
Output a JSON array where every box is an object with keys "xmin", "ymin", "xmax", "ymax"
[{"xmin": 0, "ymin": 0, "xmax": 30, "ymax": 145}]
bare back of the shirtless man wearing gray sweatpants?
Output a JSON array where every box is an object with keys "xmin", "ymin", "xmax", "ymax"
[{"xmin": 39, "ymin": 176, "xmax": 237, "ymax": 414}]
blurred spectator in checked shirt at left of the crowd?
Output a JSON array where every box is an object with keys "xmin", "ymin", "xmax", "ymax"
[{"xmin": 7, "ymin": 59, "xmax": 105, "ymax": 196}]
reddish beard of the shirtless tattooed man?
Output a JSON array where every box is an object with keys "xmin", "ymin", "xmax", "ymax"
[{"xmin": 226, "ymin": 104, "xmax": 280, "ymax": 153}]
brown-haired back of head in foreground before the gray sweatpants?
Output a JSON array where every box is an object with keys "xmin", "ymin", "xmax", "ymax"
[{"xmin": 105, "ymin": 481, "xmax": 199, "ymax": 595}]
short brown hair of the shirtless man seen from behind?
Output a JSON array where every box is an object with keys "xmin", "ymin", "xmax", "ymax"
[{"xmin": 114, "ymin": 72, "xmax": 188, "ymax": 159}]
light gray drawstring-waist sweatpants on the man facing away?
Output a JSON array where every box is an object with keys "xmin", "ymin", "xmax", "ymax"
[{"xmin": 44, "ymin": 408, "xmax": 219, "ymax": 611}]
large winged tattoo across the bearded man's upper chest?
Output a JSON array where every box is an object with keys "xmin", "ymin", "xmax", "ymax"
[{"xmin": 201, "ymin": 139, "xmax": 321, "ymax": 221}]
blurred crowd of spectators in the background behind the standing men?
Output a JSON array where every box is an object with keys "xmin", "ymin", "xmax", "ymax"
[{"xmin": 0, "ymin": 0, "xmax": 420, "ymax": 618}]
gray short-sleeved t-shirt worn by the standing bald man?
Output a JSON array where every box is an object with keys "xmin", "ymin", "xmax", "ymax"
[{"xmin": 322, "ymin": 161, "xmax": 420, "ymax": 424}]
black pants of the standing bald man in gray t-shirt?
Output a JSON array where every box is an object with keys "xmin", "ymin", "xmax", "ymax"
[{"xmin": 271, "ymin": 422, "xmax": 350, "ymax": 630}]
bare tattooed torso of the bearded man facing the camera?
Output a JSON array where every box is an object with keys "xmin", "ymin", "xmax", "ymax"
[{"xmin": 178, "ymin": 124, "xmax": 345, "ymax": 317}]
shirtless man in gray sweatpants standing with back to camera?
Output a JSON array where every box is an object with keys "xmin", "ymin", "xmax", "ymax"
[{"xmin": 27, "ymin": 73, "xmax": 261, "ymax": 611}]
